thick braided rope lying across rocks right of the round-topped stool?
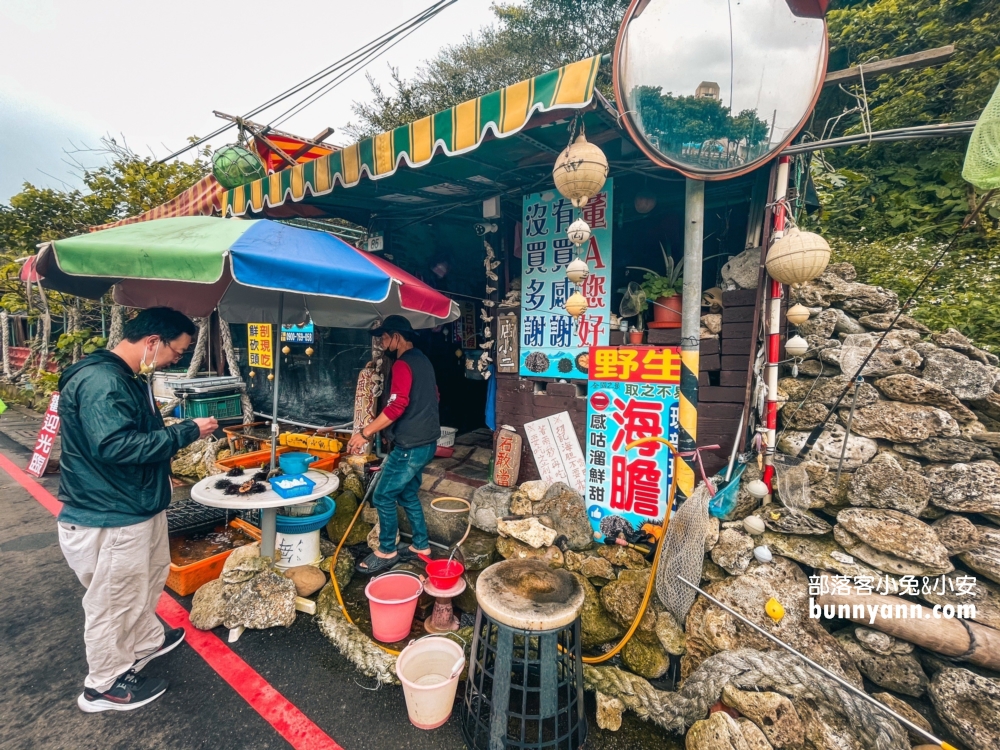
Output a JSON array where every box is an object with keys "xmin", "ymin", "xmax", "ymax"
[{"xmin": 583, "ymin": 649, "xmax": 910, "ymax": 750}]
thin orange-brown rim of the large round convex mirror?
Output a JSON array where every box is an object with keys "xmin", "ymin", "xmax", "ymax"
[{"xmin": 612, "ymin": 0, "xmax": 830, "ymax": 182}]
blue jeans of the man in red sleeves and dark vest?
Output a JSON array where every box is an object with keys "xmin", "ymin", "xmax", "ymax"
[{"xmin": 372, "ymin": 443, "xmax": 437, "ymax": 555}]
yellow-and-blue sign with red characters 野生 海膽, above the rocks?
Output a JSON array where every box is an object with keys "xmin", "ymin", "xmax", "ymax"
[{"xmin": 585, "ymin": 346, "xmax": 681, "ymax": 540}]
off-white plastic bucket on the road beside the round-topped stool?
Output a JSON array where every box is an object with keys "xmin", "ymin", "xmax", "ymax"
[{"xmin": 396, "ymin": 636, "xmax": 465, "ymax": 729}]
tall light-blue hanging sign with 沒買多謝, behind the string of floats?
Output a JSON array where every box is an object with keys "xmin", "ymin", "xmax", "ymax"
[{"xmin": 520, "ymin": 179, "xmax": 614, "ymax": 380}]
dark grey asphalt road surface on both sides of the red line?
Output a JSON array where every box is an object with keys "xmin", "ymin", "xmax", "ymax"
[{"xmin": 0, "ymin": 433, "xmax": 682, "ymax": 750}]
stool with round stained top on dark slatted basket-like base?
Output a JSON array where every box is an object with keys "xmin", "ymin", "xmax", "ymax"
[{"xmin": 460, "ymin": 560, "xmax": 587, "ymax": 750}]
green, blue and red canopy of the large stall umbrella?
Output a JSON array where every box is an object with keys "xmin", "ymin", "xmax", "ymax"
[{"xmin": 33, "ymin": 216, "xmax": 459, "ymax": 328}]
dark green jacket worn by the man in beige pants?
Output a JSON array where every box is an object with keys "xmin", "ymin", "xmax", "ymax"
[{"xmin": 59, "ymin": 349, "xmax": 198, "ymax": 526}]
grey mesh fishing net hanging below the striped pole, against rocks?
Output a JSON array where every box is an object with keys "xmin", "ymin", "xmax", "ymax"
[{"xmin": 656, "ymin": 482, "xmax": 710, "ymax": 624}]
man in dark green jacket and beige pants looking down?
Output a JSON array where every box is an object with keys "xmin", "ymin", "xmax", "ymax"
[{"xmin": 58, "ymin": 307, "xmax": 218, "ymax": 713}]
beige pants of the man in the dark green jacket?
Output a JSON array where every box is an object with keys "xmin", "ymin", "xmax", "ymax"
[{"xmin": 58, "ymin": 512, "xmax": 170, "ymax": 692}]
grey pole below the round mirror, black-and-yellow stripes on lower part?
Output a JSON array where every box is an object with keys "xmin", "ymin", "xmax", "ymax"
[{"xmin": 677, "ymin": 178, "xmax": 705, "ymax": 497}]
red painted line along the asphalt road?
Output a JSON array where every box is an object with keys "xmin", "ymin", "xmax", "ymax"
[{"xmin": 0, "ymin": 454, "xmax": 344, "ymax": 750}]
